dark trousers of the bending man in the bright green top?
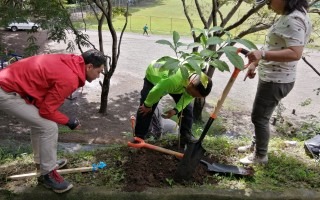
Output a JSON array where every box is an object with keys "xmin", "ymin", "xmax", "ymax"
[{"xmin": 135, "ymin": 78, "xmax": 193, "ymax": 139}]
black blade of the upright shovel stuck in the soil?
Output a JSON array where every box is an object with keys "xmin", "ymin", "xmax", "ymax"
[{"xmin": 174, "ymin": 142, "xmax": 206, "ymax": 181}]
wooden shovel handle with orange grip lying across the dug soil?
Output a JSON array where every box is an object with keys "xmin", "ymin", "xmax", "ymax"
[{"xmin": 128, "ymin": 137, "xmax": 183, "ymax": 158}]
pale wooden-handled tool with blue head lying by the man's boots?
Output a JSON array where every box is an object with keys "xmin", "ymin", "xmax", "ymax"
[{"xmin": 8, "ymin": 162, "xmax": 107, "ymax": 180}]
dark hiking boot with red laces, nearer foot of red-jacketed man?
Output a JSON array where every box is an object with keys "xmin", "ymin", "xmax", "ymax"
[{"xmin": 39, "ymin": 170, "xmax": 73, "ymax": 193}]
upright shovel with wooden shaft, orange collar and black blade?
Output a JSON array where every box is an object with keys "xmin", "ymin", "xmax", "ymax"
[{"xmin": 174, "ymin": 48, "xmax": 248, "ymax": 181}]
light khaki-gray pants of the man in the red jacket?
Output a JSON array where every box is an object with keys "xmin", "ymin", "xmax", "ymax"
[{"xmin": 0, "ymin": 88, "xmax": 58, "ymax": 175}]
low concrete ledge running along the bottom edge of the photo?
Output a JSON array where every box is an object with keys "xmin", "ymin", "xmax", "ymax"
[{"xmin": 0, "ymin": 186, "xmax": 320, "ymax": 200}]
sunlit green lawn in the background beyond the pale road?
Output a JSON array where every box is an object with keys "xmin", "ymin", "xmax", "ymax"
[{"xmin": 73, "ymin": 0, "xmax": 320, "ymax": 47}]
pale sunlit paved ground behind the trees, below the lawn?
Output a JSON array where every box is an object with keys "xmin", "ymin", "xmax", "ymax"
[{"xmin": 49, "ymin": 31, "xmax": 320, "ymax": 117}]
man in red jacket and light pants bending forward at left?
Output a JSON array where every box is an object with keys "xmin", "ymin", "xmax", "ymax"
[{"xmin": 0, "ymin": 50, "xmax": 106, "ymax": 193}]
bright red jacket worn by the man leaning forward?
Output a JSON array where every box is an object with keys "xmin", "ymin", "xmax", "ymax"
[{"xmin": 0, "ymin": 54, "xmax": 86, "ymax": 124}]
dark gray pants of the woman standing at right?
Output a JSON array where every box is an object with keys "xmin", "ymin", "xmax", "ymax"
[{"xmin": 251, "ymin": 80, "xmax": 294, "ymax": 156}]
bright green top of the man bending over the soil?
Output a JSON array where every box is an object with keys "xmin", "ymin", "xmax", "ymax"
[{"xmin": 144, "ymin": 62, "xmax": 193, "ymax": 112}]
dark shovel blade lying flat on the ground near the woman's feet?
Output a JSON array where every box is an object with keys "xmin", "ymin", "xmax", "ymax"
[{"xmin": 200, "ymin": 160, "xmax": 254, "ymax": 176}]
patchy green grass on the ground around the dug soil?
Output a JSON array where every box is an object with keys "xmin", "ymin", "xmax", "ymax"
[{"xmin": 0, "ymin": 115, "xmax": 320, "ymax": 194}]
